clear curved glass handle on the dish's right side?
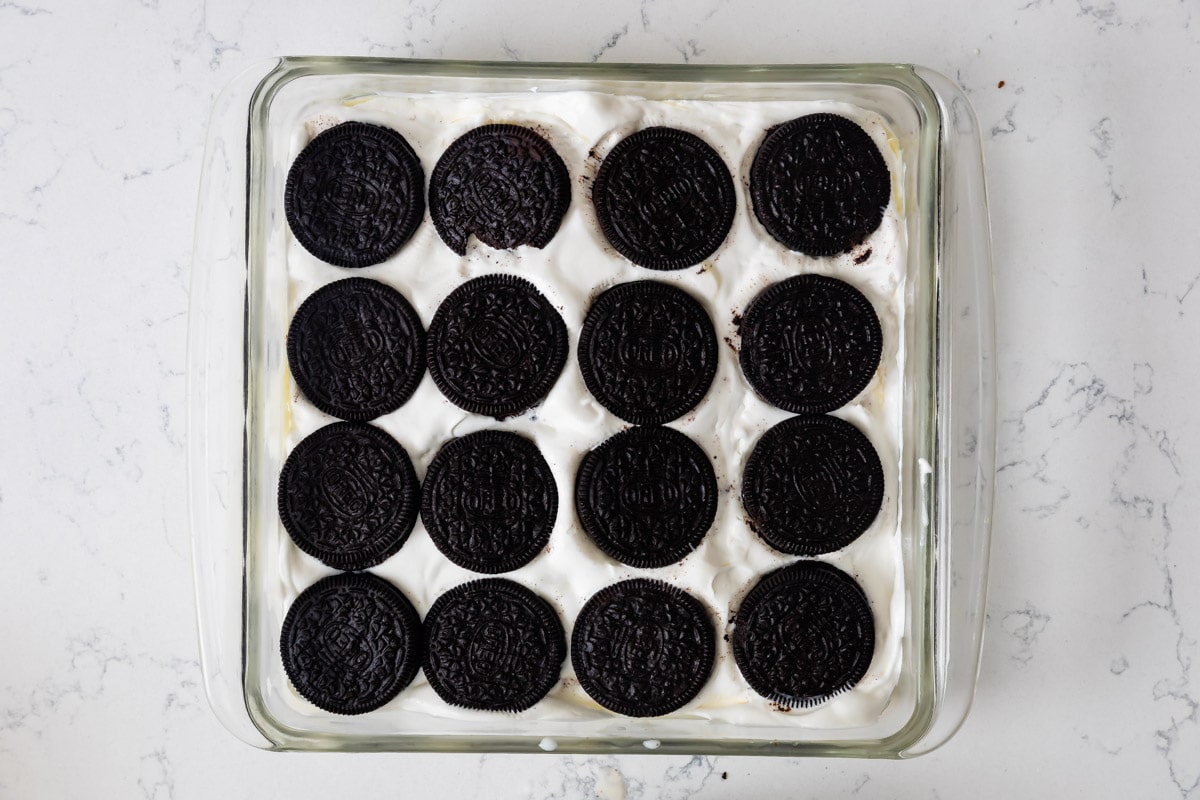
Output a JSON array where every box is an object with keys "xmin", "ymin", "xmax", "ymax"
[{"xmin": 902, "ymin": 67, "xmax": 996, "ymax": 756}]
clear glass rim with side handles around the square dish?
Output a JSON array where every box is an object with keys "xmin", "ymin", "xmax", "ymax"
[{"xmin": 188, "ymin": 58, "xmax": 995, "ymax": 757}]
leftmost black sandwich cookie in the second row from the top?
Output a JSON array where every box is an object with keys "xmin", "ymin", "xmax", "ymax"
[{"xmin": 288, "ymin": 278, "xmax": 425, "ymax": 421}]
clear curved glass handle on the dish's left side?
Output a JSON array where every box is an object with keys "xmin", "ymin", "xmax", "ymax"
[{"xmin": 187, "ymin": 59, "xmax": 278, "ymax": 747}]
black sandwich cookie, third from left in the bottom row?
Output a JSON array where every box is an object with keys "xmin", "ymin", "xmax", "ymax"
[{"xmin": 571, "ymin": 578, "xmax": 716, "ymax": 717}]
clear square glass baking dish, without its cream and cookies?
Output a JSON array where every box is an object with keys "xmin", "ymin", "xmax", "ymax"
[{"xmin": 188, "ymin": 58, "xmax": 995, "ymax": 758}]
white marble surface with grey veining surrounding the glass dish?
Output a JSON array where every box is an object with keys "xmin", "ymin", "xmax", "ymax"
[{"xmin": 0, "ymin": 0, "xmax": 1200, "ymax": 800}]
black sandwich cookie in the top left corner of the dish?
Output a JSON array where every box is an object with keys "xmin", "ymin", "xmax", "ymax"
[{"xmin": 283, "ymin": 122, "xmax": 425, "ymax": 266}]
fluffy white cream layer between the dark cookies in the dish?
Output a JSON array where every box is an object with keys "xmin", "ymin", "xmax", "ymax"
[{"xmin": 262, "ymin": 91, "xmax": 911, "ymax": 735}]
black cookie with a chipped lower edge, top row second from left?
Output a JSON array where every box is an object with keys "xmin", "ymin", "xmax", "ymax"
[{"xmin": 430, "ymin": 125, "xmax": 571, "ymax": 255}]
